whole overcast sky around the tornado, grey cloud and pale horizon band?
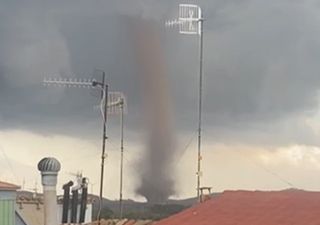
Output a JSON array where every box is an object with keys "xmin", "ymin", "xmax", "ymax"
[{"xmin": 0, "ymin": 0, "xmax": 320, "ymax": 198}]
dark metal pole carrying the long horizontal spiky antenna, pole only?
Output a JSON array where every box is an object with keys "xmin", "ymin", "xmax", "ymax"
[{"xmin": 97, "ymin": 72, "xmax": 108, "ymax": 225}]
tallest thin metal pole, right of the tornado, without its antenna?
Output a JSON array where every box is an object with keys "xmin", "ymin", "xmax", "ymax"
[{"xmin": 197, "ymin": 18, "xmax": 203, "ymax": 202}]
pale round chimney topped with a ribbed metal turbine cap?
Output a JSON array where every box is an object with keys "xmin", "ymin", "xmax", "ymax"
[{"xmin": 38, "ymin": 157, "xmax": 61, "ymax": 225}]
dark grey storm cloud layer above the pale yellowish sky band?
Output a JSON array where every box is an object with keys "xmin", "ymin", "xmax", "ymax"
[{"xmin": 0, "ymin": 0, "xmax": 320, "ymax": 144}]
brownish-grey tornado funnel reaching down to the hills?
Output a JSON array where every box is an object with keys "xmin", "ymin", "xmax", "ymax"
[{"xmin": 131, "ymin": 19, "xmax": 175, "ymax": 203}]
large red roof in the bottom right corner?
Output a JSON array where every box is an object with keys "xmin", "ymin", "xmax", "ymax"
[{"xmin": 155, "ymin": 190, "xmax": 320, "ymax": 225}]
